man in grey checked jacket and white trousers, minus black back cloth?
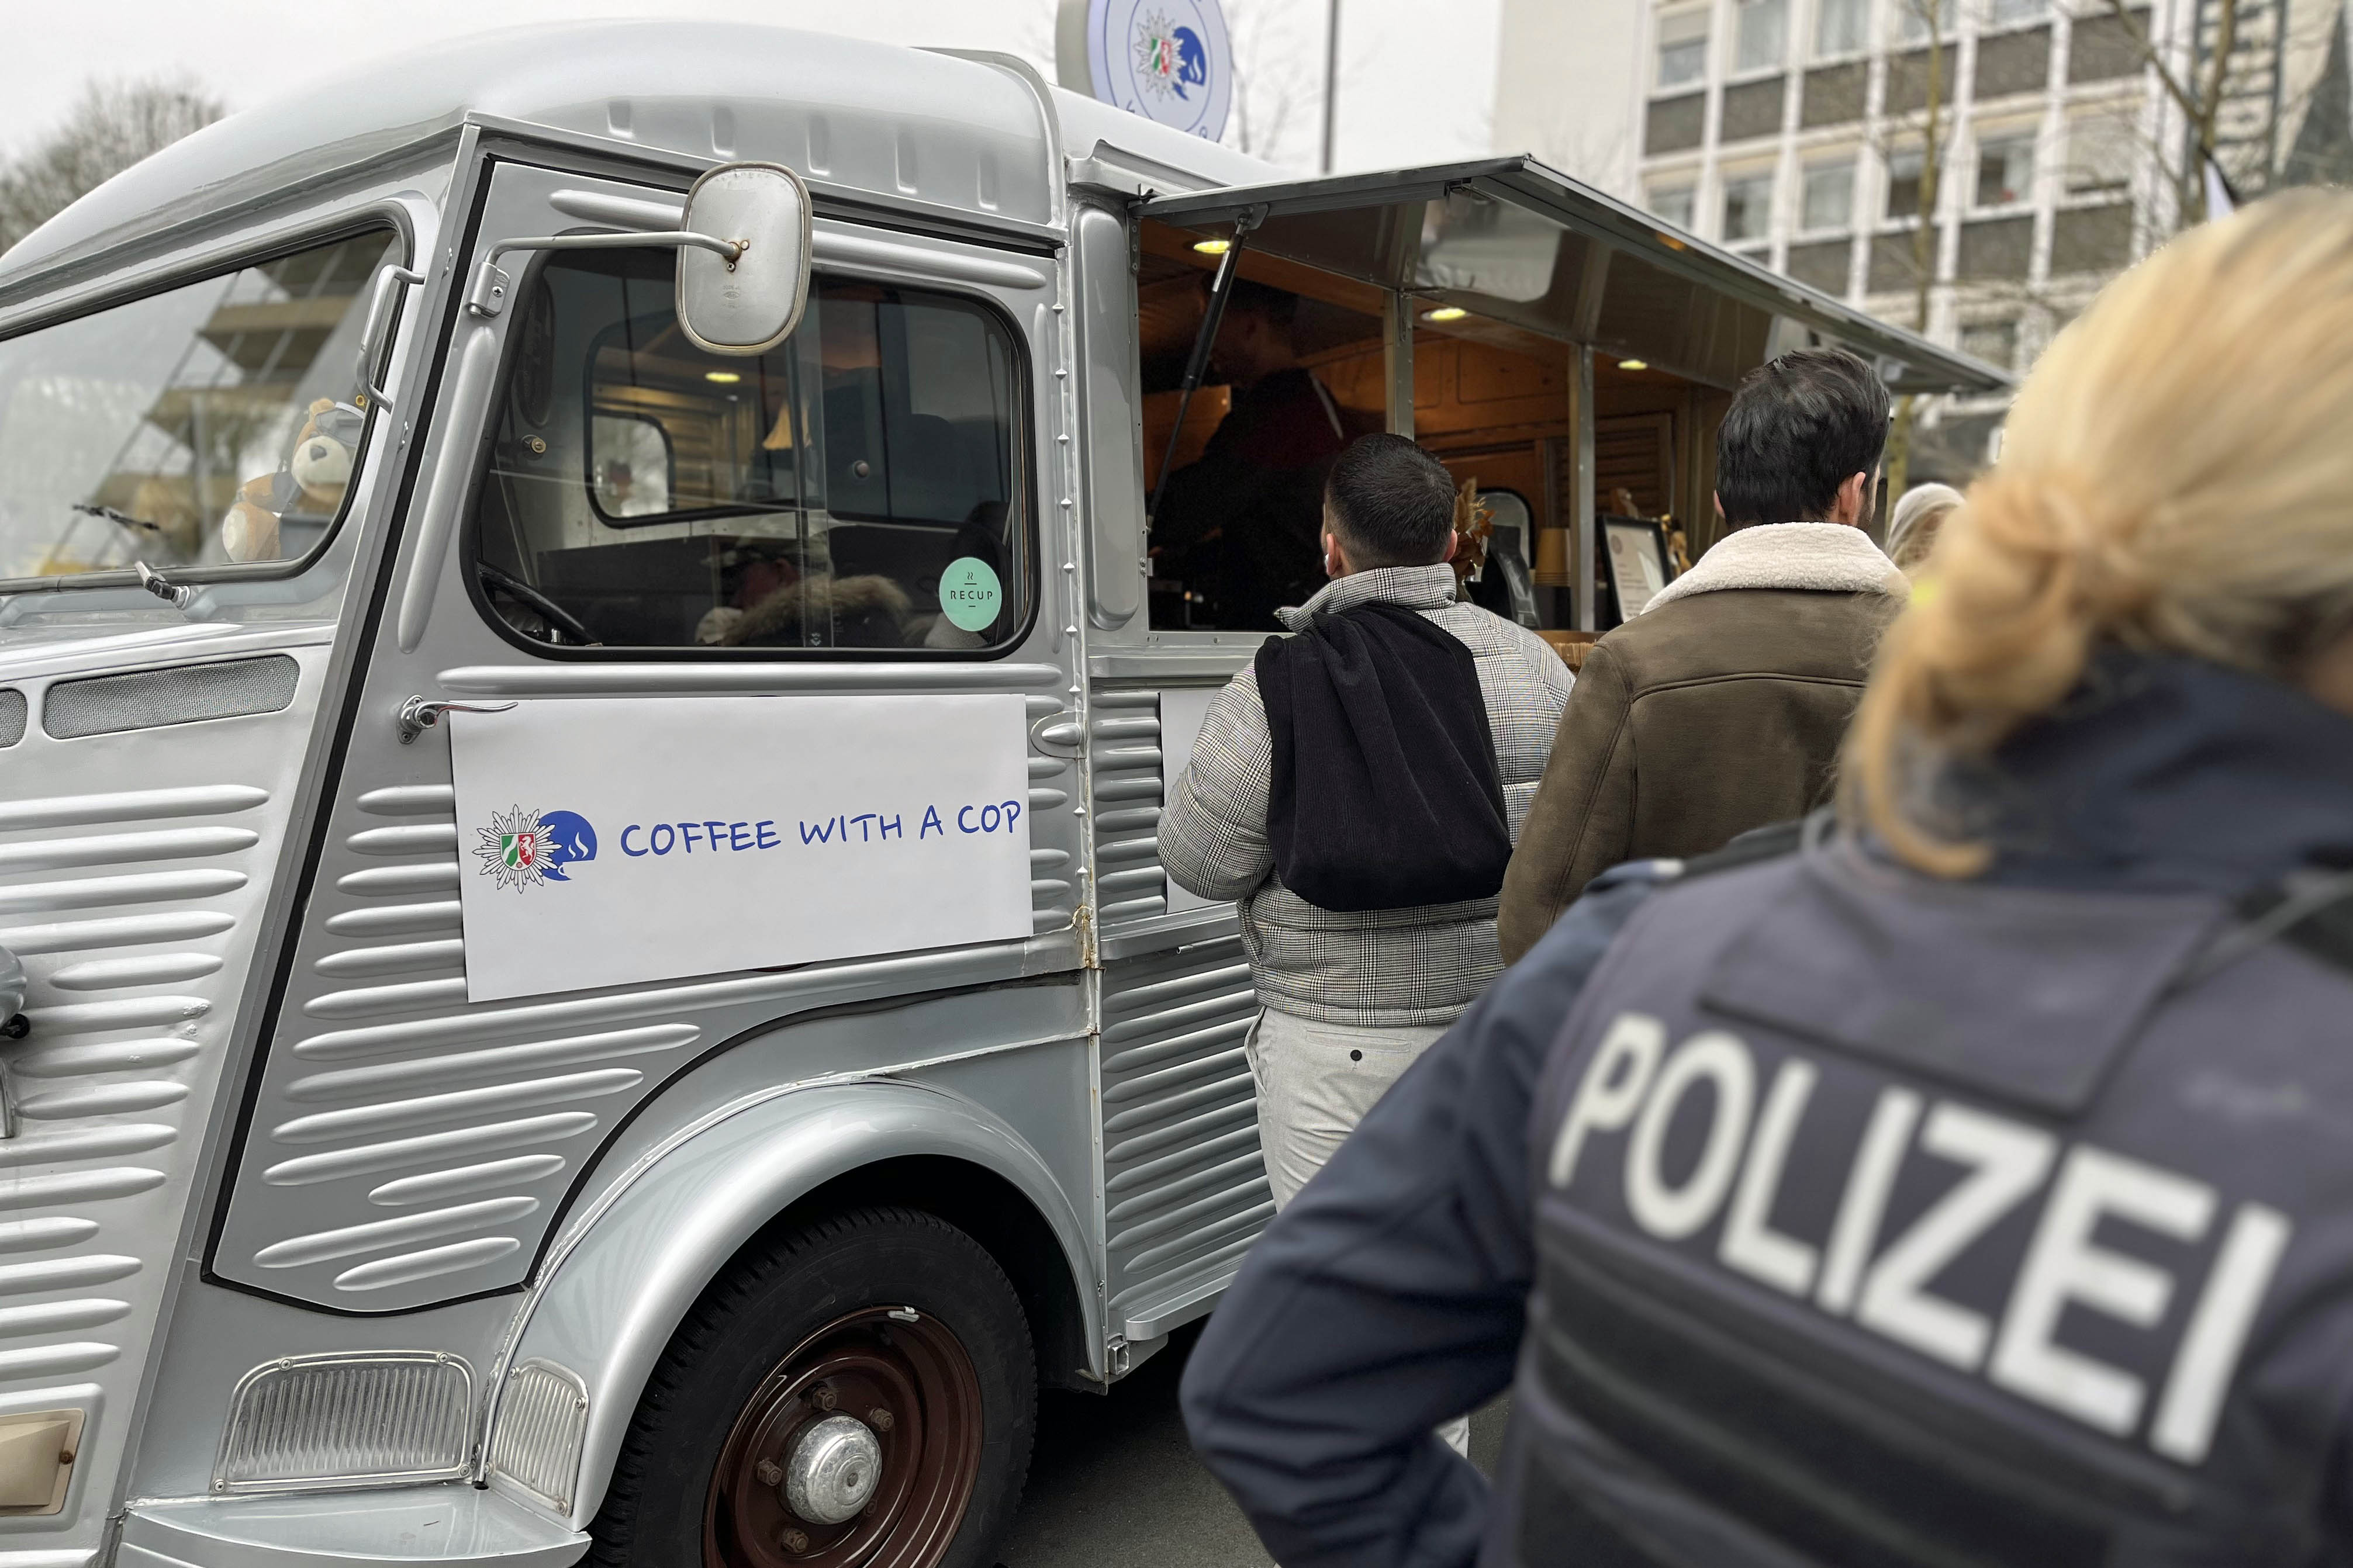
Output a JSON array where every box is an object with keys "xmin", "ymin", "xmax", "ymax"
[{"xmin": 1160, "ymin": 435, "xmax": 1572, "ymax": 1401}]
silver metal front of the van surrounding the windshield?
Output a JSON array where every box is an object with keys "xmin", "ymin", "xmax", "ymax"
[{"xmin": 0, "ymin": 144, "xmax": 465, "ymax": 1563}]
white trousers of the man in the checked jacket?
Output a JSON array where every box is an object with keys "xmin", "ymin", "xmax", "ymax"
[{"xmin": 1242, "ymin": 1009, "xmax": 1471, "ymax": 1458}]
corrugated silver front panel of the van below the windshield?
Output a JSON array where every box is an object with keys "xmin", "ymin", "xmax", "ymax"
[{"xmin": 0, "ymin": 628, "xmax": 324, "ymax": 1561}]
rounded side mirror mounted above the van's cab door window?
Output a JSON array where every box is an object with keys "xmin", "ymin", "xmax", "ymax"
[{"xmin": 678, "ymin": 162, "xmax": 812, "ymax": 357}]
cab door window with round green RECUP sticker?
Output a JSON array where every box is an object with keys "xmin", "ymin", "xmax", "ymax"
[{"xmin": 473, "ymin": 249, "xmax": 1033, "ymax": 651}]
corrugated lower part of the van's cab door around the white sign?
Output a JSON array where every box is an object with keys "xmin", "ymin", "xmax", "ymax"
[{"xmin": 219, "ymin": 696, "xmax": 1083, "ymax": 1312}]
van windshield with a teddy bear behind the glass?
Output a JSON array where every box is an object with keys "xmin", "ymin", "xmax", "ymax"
[{"xmin": 0, "ymin": 233, "xmax": 393, "ymax": 579}]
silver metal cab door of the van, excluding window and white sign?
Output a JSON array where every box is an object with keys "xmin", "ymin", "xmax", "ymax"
[{"xmin": 209, "ymin": 162, "xmax": 1085, "ymax": 1312}]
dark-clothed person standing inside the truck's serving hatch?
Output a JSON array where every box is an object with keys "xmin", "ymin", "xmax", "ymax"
[{"xmin": 1150, "ymin": 278, "xmax": 1353, "ymax": 632}]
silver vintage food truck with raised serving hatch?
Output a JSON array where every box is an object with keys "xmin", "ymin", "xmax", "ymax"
[{"xmin": 0, "ymin": 23, "xmax": 2002, "ymax": 1568}]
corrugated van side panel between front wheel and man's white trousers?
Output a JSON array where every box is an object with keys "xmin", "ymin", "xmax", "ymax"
[{"xmin": 1101, "ymin": 938, "xmax": 1276, "ymax": 1324}]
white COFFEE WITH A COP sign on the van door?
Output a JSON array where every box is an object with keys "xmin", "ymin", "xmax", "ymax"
[{"xmin": 450, "ymin": 696, "xmax": 1031, "ymax": 1002}]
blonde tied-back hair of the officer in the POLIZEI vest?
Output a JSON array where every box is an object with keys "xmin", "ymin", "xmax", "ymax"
[{"xmin": 1840, "ymin": 191, "xmax": 2353, "ymax": 877}]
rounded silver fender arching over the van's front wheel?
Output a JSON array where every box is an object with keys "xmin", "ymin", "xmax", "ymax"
[{"xmin": 482, "ymin": 1079, "xmax": 1104, "ymax": 1528}]
